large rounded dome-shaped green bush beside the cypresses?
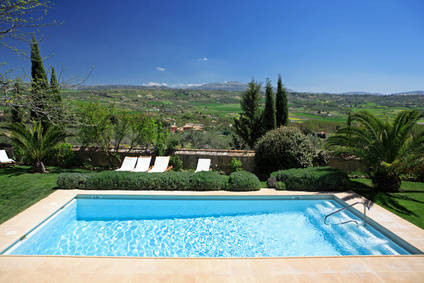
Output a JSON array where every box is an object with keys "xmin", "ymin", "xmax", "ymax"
[{"xmin": 255, "ymin": 126, "xmax": 315, "ymax": 178}]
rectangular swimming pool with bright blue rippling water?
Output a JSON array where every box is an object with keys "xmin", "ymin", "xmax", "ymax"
[{"xmin": 3, "ymin": 195, "xmax": 419, "ymax": 257}]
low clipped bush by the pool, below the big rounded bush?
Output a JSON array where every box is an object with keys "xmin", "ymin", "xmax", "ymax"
[{"xmin": 268, "ymin": 167, "xmax": 350, "ymax": 191}]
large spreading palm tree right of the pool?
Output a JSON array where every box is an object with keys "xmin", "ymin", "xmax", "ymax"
[{"xmin": 326, "ymin": 111, "xmax": 424, "ymax": 191}]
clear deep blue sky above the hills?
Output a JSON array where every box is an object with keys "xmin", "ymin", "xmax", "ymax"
[{"xmin": 0, "ymin": 0, "xmax": 424, "ymax": 93}]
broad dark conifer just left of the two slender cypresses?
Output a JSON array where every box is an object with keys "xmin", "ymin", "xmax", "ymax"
[{"xmin": 234, "ymin": 80, "xmax": 263, "ymax": 148}]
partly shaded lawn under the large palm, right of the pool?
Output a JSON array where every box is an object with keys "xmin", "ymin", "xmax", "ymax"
[{"xmin": 353, "ymin": 179, "xmax": 424, "ymax": 229}]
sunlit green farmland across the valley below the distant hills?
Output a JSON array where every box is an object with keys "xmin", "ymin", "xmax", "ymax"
[{"xmin": 62, "ymin": 89, "xmax": 424, "ymax": 132}]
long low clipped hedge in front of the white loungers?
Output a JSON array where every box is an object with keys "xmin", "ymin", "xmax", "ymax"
[{"xmin": 57, "ymin": 171, "xmax": 260, "ymax": 191}]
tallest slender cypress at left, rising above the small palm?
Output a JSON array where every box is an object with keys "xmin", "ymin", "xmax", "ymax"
[{"xmin": 30, "ymin": 36, "xmax": 49, "ymax": 126}]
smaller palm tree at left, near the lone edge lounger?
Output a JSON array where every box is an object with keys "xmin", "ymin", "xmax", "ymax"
[{"xmin": 1, "ymin": 121, "xmax": 68, "ymax": 173}]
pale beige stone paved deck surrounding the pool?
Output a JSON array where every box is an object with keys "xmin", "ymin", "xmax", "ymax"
[{"xmin": 0, "ymin": 189, "xmax": 424, "ymax": 283}]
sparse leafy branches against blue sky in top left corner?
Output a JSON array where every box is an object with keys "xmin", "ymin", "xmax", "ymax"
[{"xmin": 0, "ymin": 0, "xmax": 57, "ymax": 55}]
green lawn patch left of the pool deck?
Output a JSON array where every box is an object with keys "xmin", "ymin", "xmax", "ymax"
[{"xmin": 0, "ymin": 166, "xmax": 88, "ymax": 223}]
